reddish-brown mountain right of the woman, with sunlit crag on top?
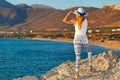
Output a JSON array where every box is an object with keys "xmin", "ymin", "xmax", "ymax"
[{"xmin": 87, "ymin": 5, "xmax": 120, "ymax": 26}]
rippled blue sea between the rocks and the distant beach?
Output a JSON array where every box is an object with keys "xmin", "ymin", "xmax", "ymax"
[{"xmin": 0, "ymin": 38, "xmax": 120, "ymax": 80}]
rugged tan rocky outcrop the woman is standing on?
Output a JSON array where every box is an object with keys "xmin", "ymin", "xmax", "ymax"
[{"xmin": 15, "ymin": 51, "xmax": 120, "ymax": 80}]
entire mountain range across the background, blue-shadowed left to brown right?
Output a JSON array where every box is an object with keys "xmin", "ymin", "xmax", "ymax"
[{"xmin": 0, "ymin": 0, "xmax": 120, "ymax": 30}]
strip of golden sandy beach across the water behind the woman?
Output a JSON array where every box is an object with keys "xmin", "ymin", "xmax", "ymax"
[{"xmin": 27, "ymin": 38, "xmax": 120, "ymax": 50}]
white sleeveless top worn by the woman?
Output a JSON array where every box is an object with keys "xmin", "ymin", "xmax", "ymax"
[{"xmin": 75, "ymin": 19, "xmax": 88, "ymax": 36}]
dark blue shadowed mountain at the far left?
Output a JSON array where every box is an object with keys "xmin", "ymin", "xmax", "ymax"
[{"xmin": 0, "ymin": 0, "xmax": 27, "ymax": 27}]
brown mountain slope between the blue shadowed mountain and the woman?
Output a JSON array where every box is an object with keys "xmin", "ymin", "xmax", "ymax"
[{"xmin": 12, "ymin": 8, "xmax": 67, "ymax": 29}]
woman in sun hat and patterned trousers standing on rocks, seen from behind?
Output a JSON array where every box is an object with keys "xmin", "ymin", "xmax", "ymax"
[{"xmin": 63, "ymin": 8, "xmax": 93, "ymax": 78}]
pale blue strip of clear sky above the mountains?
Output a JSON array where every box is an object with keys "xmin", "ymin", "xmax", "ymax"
[{"xmin": 7, "ymin": 0, "xmax": 120, "ymax": 9}]
